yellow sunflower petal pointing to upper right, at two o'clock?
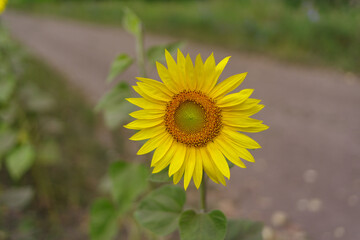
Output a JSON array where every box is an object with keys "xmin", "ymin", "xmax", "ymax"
[{"xmin": 209, "ymin": 73, "xmax": 247, "ymax": 99}]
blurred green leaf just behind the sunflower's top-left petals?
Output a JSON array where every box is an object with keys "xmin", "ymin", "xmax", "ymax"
[{"xmin": 146, "ymin": 41, "xmax": 185, "ymax": 64}]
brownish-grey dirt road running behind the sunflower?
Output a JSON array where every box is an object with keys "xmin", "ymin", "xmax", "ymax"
[{"xmin": 5, "ymin": 13, "xmax": 360, "ymax": 240}]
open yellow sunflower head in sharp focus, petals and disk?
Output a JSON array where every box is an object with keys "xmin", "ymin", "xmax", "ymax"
[{"xmin": 124, "ymin": 50, "xmax": 268, "ymax": 190}]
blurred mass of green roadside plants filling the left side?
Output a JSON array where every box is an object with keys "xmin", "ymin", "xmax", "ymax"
[{"xmin": 0, "ymin": 28, "xmax": 108, "ymax": 240}]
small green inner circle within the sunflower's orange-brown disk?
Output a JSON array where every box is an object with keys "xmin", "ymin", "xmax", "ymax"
[{"xmin": 175, "ymin": 101, "xmax": 205, "ymax": 133}]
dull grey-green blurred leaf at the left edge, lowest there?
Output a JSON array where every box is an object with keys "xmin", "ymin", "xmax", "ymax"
[{"xmin": 0, "ymin": 186, "xmax": 34, "ymax": 210}]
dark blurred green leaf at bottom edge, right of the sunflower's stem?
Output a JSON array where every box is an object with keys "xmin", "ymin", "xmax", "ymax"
[{"xmin": 225, "ymin": 219, "xmax": 264, "ymax": 240}]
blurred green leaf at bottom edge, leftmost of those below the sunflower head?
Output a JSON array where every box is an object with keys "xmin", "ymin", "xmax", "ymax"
[{"xmin": 90, "ymin": 199, "xmax": 118, "ymax": 240}]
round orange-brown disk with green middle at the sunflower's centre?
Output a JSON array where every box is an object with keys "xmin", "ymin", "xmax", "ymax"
[{"xmin": 165, "ymin": 91, "xmax": 222, "ymax": 147}]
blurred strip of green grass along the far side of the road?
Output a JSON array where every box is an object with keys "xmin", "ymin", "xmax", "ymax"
[{"xmin": 10, "ymin": 0, "xmax": 360, "ymax": 73}]
